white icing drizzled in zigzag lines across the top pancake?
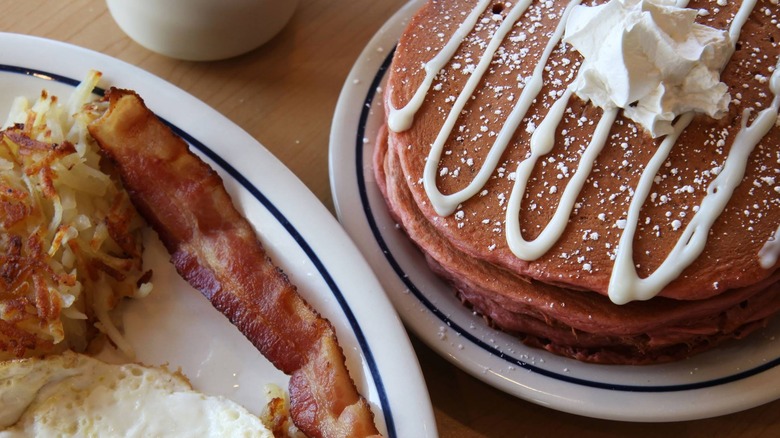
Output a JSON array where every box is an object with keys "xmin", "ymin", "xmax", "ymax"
[{"xmin": 388, "ymin": 0, "xmax": 780, "ymax": 304}]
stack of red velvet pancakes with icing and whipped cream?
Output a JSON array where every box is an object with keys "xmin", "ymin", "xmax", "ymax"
[{"xmin": 375, "ymin": 0, "xmax": 780, "ymax": 364}]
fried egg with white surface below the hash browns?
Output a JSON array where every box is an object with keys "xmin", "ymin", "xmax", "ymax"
[{"xmin": 0, "ymin": 352, "xmax": 273, "ymax": 438}]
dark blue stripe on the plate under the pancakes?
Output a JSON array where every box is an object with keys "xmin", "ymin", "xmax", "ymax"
[{"xmin": 355, "ymin": 49, "xmax": 780, "ymax": 393}]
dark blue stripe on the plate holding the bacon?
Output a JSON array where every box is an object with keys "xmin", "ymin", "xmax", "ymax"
[{"xmin": 0, "ymin": 64, "xmax": 397, "ymax": 437}]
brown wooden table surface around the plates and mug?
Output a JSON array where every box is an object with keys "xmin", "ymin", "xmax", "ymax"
[{"xmin": 0, "ymin": 0, "xmax": 780, "ymax": 438}]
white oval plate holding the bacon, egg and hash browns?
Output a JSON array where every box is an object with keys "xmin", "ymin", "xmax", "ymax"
[{"xmin": 0, "ymin": 33, "xmax": 436, "ymax": 437}]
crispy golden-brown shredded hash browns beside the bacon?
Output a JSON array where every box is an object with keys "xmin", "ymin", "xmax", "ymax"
[{"xmin": 0, "ymin": 72, "xmax": 151, "ymax": 360}]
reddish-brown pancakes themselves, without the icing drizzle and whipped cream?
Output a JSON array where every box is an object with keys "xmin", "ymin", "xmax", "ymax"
[{"xmin": 375, "ymin": 0, "xmax": 780, "ymax": 363}]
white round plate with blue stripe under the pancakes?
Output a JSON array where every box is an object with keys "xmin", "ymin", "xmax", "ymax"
[{"xmin": 330, "ymin": 0, "xmax": 780, "ymax": 421}]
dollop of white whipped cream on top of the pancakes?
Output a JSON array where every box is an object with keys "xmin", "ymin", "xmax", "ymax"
[{"xmin": 563, "ymin": 0, "xmax": 734, "ymax": 137}]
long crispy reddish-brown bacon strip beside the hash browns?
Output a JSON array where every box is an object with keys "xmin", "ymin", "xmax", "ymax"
[{"xmin": 89, "ymin": 89, "xmax": 378, "ymax": 437}]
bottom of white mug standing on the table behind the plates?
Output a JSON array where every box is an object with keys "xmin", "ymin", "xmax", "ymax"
[{"xmin": 106, "ymin": 0, "xmax": 298, "ymax": 61}]
